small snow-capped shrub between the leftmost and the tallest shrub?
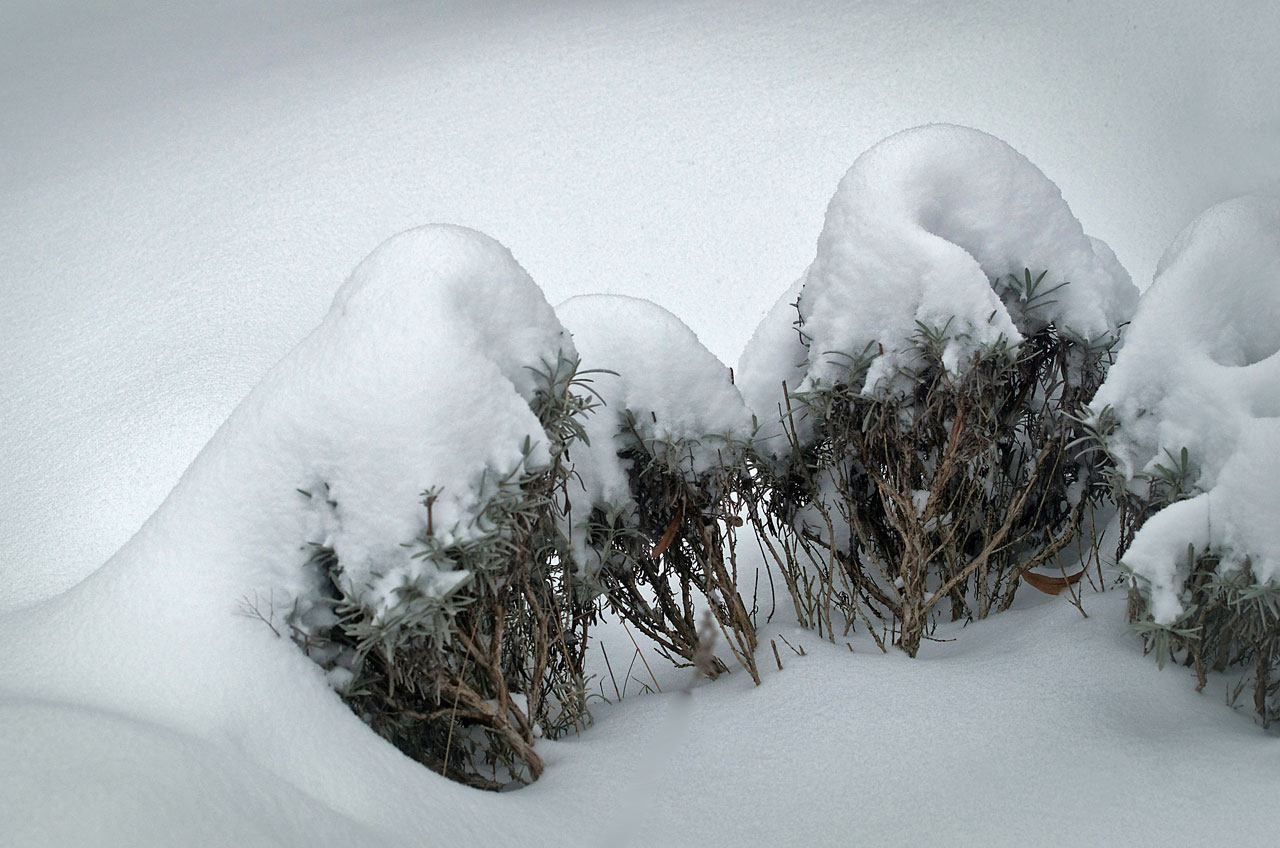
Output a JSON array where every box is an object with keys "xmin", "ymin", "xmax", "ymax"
[{"xmin": 557, "ymin": 295, "xmax": 759, "ymax": 683}]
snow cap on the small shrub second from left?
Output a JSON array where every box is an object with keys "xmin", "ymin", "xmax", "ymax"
[{"xmin": 556, "ymin": 295, "xmax": 753, "ymax": 525}]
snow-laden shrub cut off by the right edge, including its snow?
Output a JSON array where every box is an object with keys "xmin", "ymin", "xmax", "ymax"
[{"xmin": 1093, "ymin": 196, "xmax": 1280, "ymax": 722}]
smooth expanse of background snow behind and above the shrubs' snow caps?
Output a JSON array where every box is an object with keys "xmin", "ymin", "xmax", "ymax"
[{"xmin": 10, "ymin": 0, "xmax": 1280, "ymax": 608}]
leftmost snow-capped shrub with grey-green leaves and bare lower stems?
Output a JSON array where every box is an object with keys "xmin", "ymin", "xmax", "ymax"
[{"xmin": 280, "ymin": 227, "xmax": 596, "ymax": 789}]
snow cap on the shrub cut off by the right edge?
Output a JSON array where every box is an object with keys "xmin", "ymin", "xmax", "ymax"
[{"xmin": 1093, "ymin": 196, "xmax": 1280, "ymax": 623}]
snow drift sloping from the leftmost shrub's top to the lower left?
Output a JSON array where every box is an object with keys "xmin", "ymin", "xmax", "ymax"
[{"xmin": 0, "ymin": 227, "xmax": 573, "ymax": 844}]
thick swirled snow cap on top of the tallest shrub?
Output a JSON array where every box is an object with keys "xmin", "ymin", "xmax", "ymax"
[{"xmin": 739, "ymin": 124, "xmax": 1138, "ymax": 445}]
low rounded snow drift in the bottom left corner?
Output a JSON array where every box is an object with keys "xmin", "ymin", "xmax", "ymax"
[{"xmin": 0, "ymin": 701, "xmax": 397, "ymax": 845}]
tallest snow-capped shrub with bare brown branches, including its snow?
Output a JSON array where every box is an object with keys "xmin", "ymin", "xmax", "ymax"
[{"xmin": 739, "ymin": 126, "xmax": 1137, "ymax": 655}]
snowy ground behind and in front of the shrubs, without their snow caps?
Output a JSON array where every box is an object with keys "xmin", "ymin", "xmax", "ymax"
[{"xmin": 0, "ymin": 0, "xmax": 1280, "ymax": 845}]
